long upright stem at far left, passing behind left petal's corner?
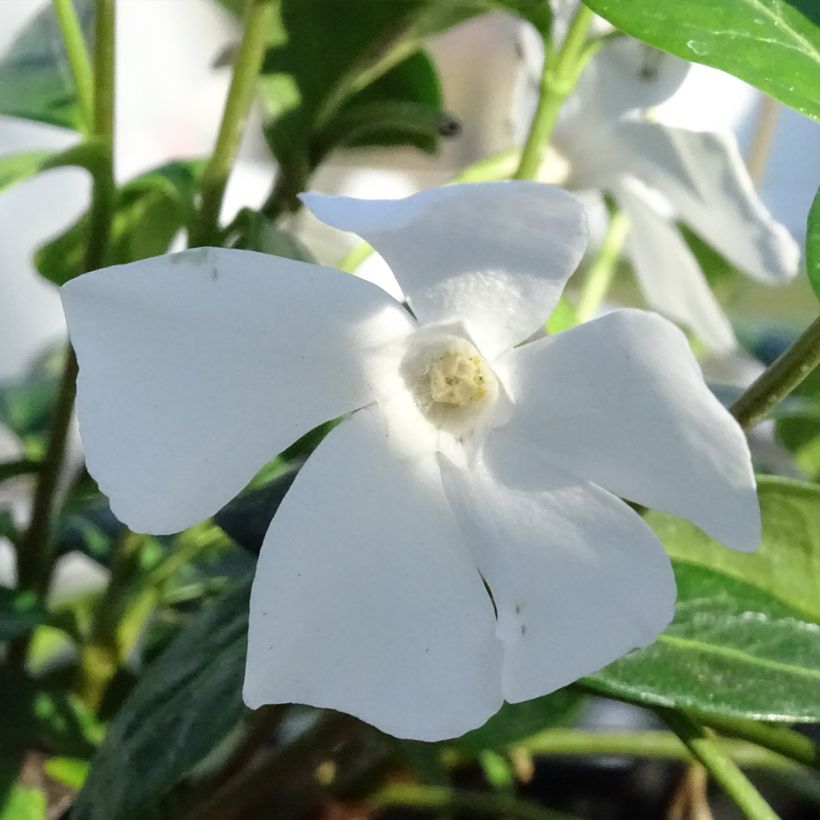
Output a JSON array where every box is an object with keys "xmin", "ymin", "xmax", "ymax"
[{"xmin": 16, "ymin": 0, "xmax": 115, "ymax": 604}]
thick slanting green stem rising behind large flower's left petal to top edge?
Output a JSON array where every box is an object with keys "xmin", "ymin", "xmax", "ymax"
[{"xmin": 190, "ymin": 0, "xmax": 274, "ymax": 247}]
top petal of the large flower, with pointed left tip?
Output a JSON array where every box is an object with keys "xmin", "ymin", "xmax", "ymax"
[{"xmin": 303, "ymin": 182, "xmax": 586, "ymax": 356}]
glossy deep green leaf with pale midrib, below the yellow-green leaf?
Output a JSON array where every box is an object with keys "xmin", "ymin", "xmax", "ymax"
[{"xmin": 587, "ymin": 561, "xmax": 820, "ymax": 723}]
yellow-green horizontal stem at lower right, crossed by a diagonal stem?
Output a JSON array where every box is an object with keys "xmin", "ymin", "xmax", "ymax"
[{"xmin": 516, "ymin": 729, "xmax": 797, "ymax": 771}]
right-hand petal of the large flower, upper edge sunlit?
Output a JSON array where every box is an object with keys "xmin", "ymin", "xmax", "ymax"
[{"xmin": 487, "ymin": 310, "xmax": 760, "ymax": 550}]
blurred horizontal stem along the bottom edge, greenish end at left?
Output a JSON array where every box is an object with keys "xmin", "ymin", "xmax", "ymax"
[{"xmin": 367, "ymin": 783, "xmax": 572, "ymax": 820}]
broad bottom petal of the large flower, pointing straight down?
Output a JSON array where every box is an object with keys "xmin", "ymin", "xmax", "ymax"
[{"xmin": 244, "ymin": 408, "xmax": 502, "ymax": 740}]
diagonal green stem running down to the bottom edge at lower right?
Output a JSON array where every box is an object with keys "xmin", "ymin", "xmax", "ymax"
[{"xmin": 658, "ymin": 709, "xmax": 778, "ymax": 820}]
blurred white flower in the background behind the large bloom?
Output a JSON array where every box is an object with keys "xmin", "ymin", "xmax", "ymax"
[{"xmin": 519, "ymin": 29, "xmax": 800, "ymax": 351}]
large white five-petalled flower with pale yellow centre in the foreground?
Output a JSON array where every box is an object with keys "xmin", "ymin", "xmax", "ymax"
[{"xmin": 63, "ymin": 182, "xmax": 759, "ymax": 740}]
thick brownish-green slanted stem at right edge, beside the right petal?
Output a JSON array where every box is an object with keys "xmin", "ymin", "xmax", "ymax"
[{"xmin": 730, "ymin": 317, "xmax": 820, "ymax": 428}]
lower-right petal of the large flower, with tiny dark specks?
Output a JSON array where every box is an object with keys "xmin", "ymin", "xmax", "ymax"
[{"xmin": 442, "ymin": 459, "xmax": 675, "ymax": 703}]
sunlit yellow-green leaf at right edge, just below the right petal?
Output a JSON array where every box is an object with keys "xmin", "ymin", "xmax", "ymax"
[{"xmin": 646, "ymin": 476, "xmax": 820, "ymax": 623}]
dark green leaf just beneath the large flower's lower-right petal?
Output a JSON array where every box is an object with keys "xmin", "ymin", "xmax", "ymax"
[{"xmin": 452, "ymin": 689, "xmax": 583, "ymax": 754}]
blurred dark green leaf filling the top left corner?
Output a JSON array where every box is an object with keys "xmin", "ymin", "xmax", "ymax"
[{"xmin": 0, "ymin": 0, "xmax": 94, "ymax": 129}]
